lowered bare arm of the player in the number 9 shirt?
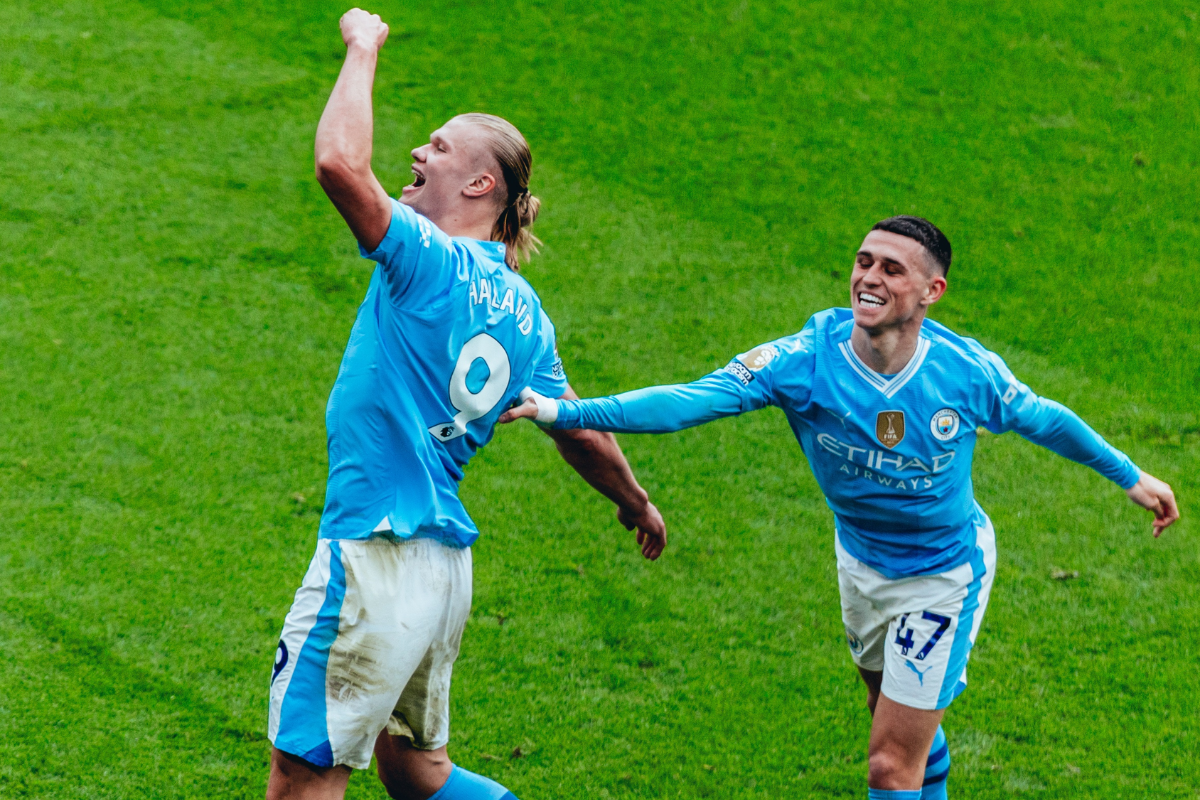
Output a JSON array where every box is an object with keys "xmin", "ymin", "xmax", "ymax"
[{"xmin": 546, "ymin": 386, "xmax": 667, "ymax": 561}]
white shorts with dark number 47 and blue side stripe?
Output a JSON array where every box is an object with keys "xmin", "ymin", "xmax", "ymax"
[{"xmin": 835, "ymin": 517, "xmax": 996, "ymax": 709}]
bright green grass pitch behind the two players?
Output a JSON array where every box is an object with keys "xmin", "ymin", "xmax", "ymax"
[{"xmin": 0, "ymin": 0, "xmax": 1200, "ymax": 800}]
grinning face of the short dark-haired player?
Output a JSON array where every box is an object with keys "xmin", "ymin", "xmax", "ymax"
[{"xmin": 850, "ymin": 230, "xmax": 946, "ymax": 335}]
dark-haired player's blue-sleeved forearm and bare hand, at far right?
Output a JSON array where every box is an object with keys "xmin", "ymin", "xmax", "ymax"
[{"xmin": 1013, "ymin": 397, "xmax": 1180, "ymax": 537}]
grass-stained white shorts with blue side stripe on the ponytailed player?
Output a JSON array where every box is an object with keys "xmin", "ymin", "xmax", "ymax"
[{"xmin": 268, "ymin": 537, "xmax": 472, "ymax": 769}]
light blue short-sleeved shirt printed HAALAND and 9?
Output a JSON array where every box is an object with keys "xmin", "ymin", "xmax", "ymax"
[{"xmin": 319, "ymin": 200, "xmax": 566, "ymax": 547}]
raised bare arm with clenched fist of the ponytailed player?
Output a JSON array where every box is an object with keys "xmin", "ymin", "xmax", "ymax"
[{"xmin": 314, "ymin": 8, "xmax": 391, "ymax": 251}]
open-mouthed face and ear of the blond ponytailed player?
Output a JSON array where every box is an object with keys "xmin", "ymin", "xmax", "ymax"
[{"xmin": 400, "ymin": 118, "xmax": 500, "ymax": 225}]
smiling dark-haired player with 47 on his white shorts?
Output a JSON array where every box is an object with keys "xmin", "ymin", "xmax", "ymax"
[{"xmin": 500, "ymin": 216, "xmax": 1178, "ymax": 800}]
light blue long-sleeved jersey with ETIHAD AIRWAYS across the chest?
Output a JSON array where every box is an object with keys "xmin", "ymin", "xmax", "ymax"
[{"xmin": 554, "ymin": 308, "xmax": 1140, "ymax": 578}]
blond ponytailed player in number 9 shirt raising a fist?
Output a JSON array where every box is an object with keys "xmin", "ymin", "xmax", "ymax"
[{"xmin": 268, "ymin": 8, "xmax": 666, "ymax": 800}]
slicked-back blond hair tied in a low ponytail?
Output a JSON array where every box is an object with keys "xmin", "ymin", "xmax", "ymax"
[{"xmin": 460, "ymin": 114, "xmax": 541, "ymax": 271}]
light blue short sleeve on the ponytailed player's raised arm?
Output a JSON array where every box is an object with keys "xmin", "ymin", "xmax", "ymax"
[{"xmin": 359, "ymin": 198, "xmax": 457, "ymax": 308}]
